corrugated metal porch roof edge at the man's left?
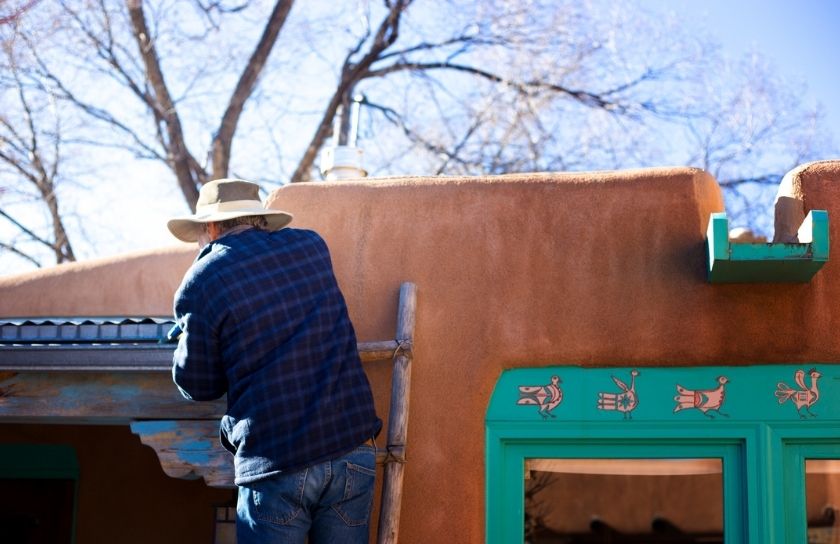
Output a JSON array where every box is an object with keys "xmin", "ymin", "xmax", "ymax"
[{"xmin": 0, "ymin": 317, "xmax": 175, "ymax": 372}]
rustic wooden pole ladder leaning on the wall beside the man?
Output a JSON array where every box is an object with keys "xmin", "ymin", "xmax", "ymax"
[{"xmin": 359, "ymin": 282, "xmax": 417, "ymax": 544}]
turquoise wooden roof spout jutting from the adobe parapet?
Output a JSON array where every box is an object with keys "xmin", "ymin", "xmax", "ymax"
[{"xmin": 706, "ymin": 210, "xmax": 829, "ymax": 283}]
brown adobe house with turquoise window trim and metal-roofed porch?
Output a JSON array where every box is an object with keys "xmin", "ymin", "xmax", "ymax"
[{"xmin": 0, "ymin": 161, "xmax": 840, "ymax": 544}]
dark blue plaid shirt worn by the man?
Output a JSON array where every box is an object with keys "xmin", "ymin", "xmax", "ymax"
[{"xmin": 172, "ymin": 228, "xmax": 382, "ymax": 484}]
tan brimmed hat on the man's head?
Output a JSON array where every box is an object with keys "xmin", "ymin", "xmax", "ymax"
[{"xmin": 166, "ymin": 178, "xmax": 292, "ymax": 242}]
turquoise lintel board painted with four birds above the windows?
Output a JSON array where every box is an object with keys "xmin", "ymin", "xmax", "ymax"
[{"xmin": 486, "ymin": 363, "xmax": 840, "ymax": 422}]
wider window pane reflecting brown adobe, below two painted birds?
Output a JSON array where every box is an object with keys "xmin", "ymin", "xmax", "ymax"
[{"xmin": 525, "ymin": 459, "xmax": 723, "ymax": 544}]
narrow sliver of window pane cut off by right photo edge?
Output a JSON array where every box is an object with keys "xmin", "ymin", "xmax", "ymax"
[{"xmin": 805, "ymin": 459, "xmax": 840, "ymax": 544}]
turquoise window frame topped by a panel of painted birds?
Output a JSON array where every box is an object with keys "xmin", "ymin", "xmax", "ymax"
[{"xmin": 485, "ymin": 364, "xmax": 840, "ymax": 544}]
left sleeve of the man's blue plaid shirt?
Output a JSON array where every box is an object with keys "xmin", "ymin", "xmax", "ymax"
[{"xmin": 172, "ymin": 268, "xmax": 228, "ymax": 400}]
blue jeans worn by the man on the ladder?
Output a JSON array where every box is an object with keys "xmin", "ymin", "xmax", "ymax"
[{"xmin": 236, "ymin": 444, "xmax": 376, "ymax": 544}]
